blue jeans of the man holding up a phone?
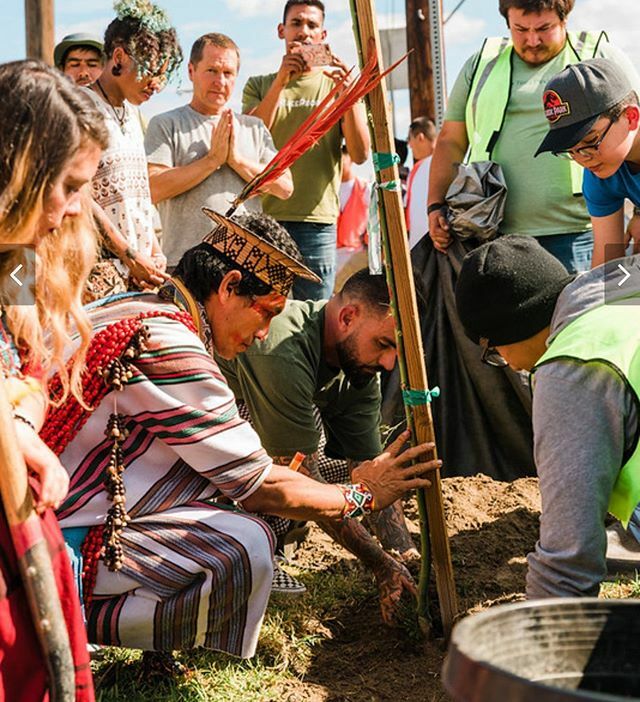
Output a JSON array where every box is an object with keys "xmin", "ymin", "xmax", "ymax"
[{"xmin": 280, "ymin": 222, "xmax": 336, "ymax": 300}]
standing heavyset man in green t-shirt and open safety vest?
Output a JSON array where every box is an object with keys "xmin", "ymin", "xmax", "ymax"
[{"xmin": 428, "ymin": 0, "xmax": 640, "ymax": 272}]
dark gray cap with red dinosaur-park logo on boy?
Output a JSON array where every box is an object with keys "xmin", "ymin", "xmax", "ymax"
[{"xmin": 535, "ymin": 58, "xmax": 633, "ymax": 156}]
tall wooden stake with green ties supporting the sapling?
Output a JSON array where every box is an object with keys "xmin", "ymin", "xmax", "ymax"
[{"xmin": 351, "ymin": 0, "xmax": 458, "ymax": 638}]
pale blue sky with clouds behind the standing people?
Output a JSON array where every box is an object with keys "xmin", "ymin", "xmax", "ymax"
[{"xmin": 0, "ymin": 0, "xmax": 640, "ymax": 143}]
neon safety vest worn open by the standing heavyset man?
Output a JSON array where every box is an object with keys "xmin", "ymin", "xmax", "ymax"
[{"xmin": 465, "ymin": 32, "xmax": 608, "ymax": 195}]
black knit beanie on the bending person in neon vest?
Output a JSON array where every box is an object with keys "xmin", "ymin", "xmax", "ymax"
[{"xmin": 456, "ymin": 234, "xmax": 574, "ymax": 346}]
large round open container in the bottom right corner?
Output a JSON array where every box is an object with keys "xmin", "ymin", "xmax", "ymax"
[{"xmin": 443, "ymin": 598, "xmax": 640, "ymax": 702}]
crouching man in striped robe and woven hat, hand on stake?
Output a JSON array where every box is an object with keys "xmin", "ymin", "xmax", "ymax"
[{"xmin": 45, "ymin": 211, "xmax": 437, "ymax": 657}]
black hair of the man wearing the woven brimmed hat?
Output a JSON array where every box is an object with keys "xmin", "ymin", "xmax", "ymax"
[{"xmin": 174, "ymin": 213, "xmax": 302, "ymax": 304}]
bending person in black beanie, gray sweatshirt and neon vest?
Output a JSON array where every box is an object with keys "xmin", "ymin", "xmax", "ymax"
[{"xmin": 456, "ymin": 236, "xmax": 640, "ymax": 598}]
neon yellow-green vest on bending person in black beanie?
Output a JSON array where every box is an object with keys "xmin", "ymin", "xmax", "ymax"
[{"xmin": 534, "ymin": 305, "xmax": 640, "ymax": 526}]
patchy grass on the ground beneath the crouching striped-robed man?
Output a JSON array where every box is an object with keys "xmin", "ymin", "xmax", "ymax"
[{"xmin": 93, "ymin": 561, "xmax": 376, "ymax": 702}]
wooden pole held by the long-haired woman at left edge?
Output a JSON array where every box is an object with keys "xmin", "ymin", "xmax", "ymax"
[{"xmin": 0, "ymin": 373, "xmax": 76, "ymax": 702}]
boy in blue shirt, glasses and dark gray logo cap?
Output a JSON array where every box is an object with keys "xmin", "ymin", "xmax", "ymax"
[{"xmin": 536, "ymin": 59, "xmax": 640, "ymax": 266}]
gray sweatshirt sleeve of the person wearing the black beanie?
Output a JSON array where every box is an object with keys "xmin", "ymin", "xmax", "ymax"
[{"xmin": 527, "ymin": 360, "xmax": 638, "ymax": 599}]
